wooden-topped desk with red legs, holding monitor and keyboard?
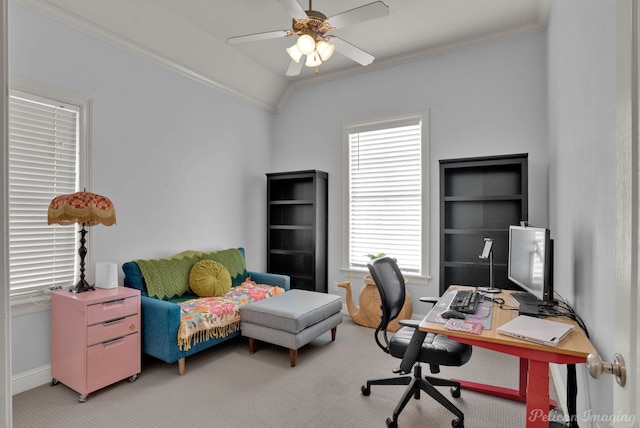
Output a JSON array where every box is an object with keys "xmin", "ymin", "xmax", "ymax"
[{"xmin": 420, "ymin": 286, "xmax": 596, "ymax": 428}]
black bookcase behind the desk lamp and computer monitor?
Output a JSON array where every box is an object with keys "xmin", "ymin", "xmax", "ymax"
[{"xmin": 440, "ymin": 154, "xmax": 528, "ymax": 295}]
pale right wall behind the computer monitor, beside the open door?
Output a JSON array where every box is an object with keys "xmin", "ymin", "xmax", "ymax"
[{"xmin": 547, "ymin": 0, "xmax": 616, "ymax": 426}]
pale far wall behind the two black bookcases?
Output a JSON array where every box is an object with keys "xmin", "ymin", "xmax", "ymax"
[{"xmin": 271, "ymin": 33, "xmax": 548, "ymax": 314}]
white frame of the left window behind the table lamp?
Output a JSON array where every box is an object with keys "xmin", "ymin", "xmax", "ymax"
[{"xmin": 7, "ymin": 75, "xmax": 93, "ymax": 315}]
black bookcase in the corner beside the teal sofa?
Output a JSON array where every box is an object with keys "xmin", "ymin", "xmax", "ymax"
[{"xmin": 267, "ymin": 170, "xmax": 328, "ymax": 293}]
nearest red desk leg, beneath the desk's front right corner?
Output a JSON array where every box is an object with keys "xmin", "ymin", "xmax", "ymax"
[{"xmin": 527, "ymin": 360, "xmax": 549, "ymax": 428}]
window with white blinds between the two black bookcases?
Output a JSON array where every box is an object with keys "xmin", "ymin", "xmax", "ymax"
[{"xmin": 344, "ymin": 112, "xmax": 429, "ymax": 277}]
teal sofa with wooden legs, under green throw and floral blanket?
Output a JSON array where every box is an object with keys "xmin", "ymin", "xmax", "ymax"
[{"xmin": 122, "ymin": 248, "xmax": 290, "ymax": 375}]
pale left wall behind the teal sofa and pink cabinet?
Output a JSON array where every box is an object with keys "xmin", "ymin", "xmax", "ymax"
[{"xmin": 9, "ymin": 3, "xmax": 272, "ymax": 375}]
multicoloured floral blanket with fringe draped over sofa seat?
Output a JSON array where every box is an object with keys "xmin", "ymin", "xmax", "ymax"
[{"xmin": 178, "ymin": 280, "xmax": 284, "ymax": 351}]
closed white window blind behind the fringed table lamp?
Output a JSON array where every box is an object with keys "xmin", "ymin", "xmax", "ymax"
[{"xmin": 9, "ymin": 91, "xmax": 79, "ymax": 297}]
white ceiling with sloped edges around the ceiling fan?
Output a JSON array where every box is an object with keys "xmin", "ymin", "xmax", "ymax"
[{"xmin": 14, "ymin": 0, "xmax": 551, "ymax": 112}]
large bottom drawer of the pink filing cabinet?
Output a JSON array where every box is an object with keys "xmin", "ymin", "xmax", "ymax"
[{"xmin": 87, "ymin": 333, "xmax": 140, "ymax": 391}]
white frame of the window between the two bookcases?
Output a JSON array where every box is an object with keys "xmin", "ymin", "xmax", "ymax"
[{"xmin": 341, "ymin": 109, "xmax": 431, "ymax": 284}]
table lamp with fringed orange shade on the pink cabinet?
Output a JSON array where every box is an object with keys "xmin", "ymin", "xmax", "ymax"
[{"xmin": 47, "ymin": 190, "xmax": 116, "ymax": 293}]
